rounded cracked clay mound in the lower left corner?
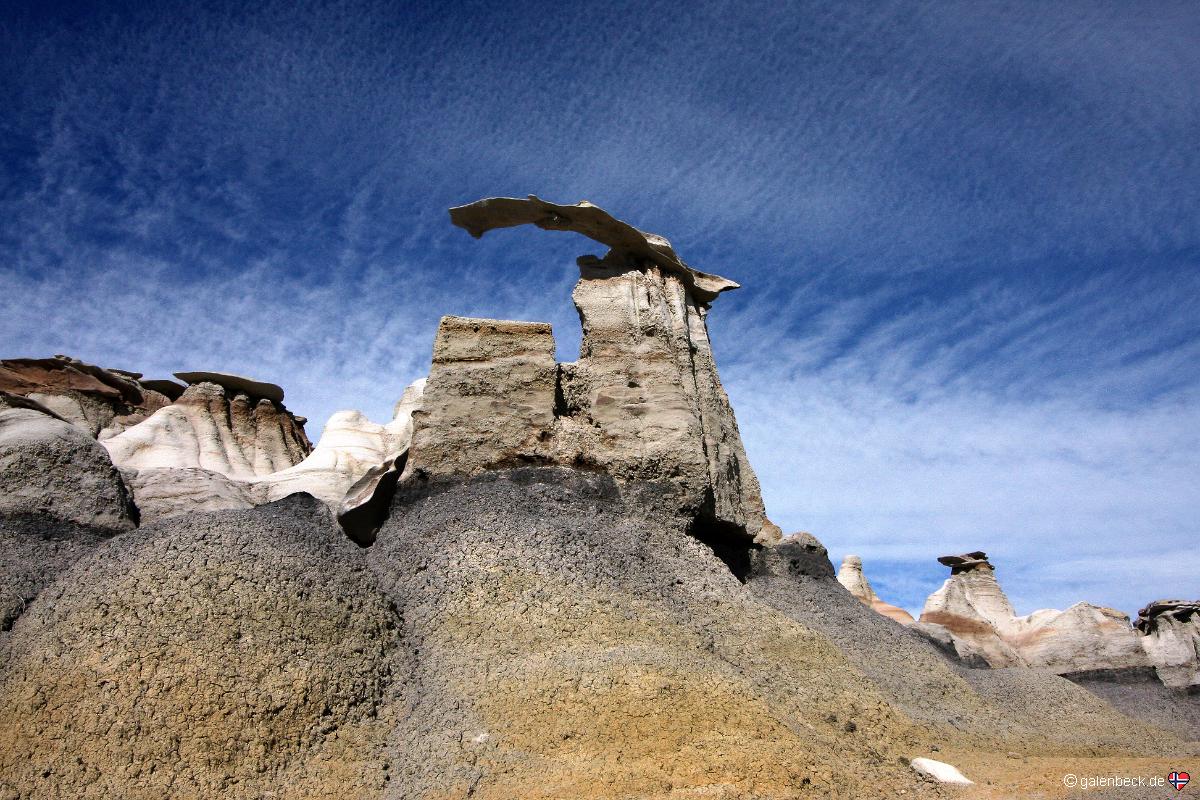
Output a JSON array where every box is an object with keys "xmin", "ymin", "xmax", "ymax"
[{"xmin": 0, "ymin": 495, "xmax": 408, "ymax": 800}]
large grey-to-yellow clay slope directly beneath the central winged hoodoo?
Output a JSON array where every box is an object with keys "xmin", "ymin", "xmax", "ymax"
[{"xmin": 367, "ymin": 468, "xmax": 937, "ymax": 798}]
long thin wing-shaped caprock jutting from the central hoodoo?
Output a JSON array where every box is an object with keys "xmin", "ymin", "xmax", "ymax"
[{"xmin": 450, "ymin": 194, "xmax": 739, "ymax": 303}]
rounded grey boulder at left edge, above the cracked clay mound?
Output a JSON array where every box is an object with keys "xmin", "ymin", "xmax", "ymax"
[{"xmin": 0, "ymin": 408, "xmax": 137, "ymax": 530}]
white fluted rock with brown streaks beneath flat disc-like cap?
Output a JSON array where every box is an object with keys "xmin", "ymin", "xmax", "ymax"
[{"xmin": 102, "ymin": 383, "xmax": 311, "ymax": 481}]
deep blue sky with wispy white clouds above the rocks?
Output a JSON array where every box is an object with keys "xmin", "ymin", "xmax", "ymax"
[{"xmin": 0, "ymin": 0, "xmax": 1200, "ymax": 612}]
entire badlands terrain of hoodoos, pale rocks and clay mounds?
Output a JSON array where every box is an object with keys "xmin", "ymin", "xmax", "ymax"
[{"xmin": 0, "ymin": 198, "xmax": 1200, "ymax": 800}]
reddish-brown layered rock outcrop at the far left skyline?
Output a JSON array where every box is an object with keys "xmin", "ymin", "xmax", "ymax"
[{"xmin": 0, "ymin": 355, "xmax": 184, "ymax": 439}]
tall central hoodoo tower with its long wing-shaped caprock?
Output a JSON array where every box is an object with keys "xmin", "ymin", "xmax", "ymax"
[{"xmin": 407, "ymin": 198, "xmax": 780, "ymax": 543}]
